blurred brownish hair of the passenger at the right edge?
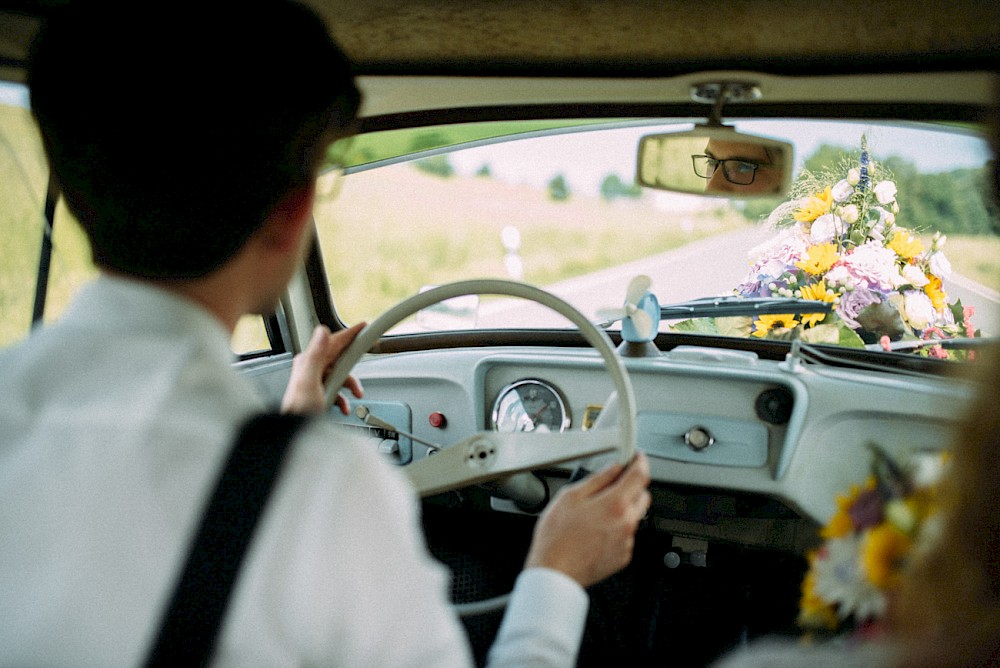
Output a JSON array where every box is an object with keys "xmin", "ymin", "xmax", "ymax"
[{"xmin": 888, "ymin": 350, "xmax": 1000, "ymax": 668}]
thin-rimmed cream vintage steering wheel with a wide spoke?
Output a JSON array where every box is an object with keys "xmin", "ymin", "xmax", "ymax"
[{"xmin": 326, "ymin": 279, "xmax": 635, "ymax": 496}]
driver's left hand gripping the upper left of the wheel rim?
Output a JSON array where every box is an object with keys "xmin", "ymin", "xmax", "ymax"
[{"xmin": 281, "ymin": 322, "xmax": 365, "ymax": 415}]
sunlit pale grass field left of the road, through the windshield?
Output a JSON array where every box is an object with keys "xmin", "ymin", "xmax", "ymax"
[{"xmin": 316, "ymin": 159, "xmax": 746, "ymax": 322}]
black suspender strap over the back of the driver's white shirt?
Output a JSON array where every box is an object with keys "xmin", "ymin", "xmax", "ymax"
[{"xmin": 146, "ymin": 414, "xmax": 307, "ymax": 668}]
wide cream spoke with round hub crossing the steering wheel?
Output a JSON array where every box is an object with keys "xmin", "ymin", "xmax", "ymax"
[{"xmin": 404, "ymin": 429, "xmax": 620, "ymax": 496}]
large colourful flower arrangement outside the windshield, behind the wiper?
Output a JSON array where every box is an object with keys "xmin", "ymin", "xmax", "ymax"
[{"xmin": 735, "ymin": 132, "xmax": 978, "ymax": 357}]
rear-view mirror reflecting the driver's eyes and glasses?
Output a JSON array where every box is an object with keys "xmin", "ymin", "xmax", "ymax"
[{"xmin": 636, "ymin": 126, "xmax": 795, "ymax": 198}]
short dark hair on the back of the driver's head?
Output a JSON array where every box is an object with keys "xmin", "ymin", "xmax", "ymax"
[{"xmin": 28, "ymin": 0, "xmax": 360, "ymax": 279}]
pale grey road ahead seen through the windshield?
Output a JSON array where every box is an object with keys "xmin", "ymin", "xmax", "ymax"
[{"xmin": 478, "ymin": 227, "xmax": 1000, "ymax": 333}]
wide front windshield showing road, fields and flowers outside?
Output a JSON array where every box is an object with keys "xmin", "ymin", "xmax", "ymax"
[{"xmin": 316, "ymin": 121, "xmax": 1000, "ymax": 354}]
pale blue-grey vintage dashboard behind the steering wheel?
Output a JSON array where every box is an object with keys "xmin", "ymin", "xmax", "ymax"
[{"xmin": 330, "ymin": 346, "xmax": 972, "ymax": 551}]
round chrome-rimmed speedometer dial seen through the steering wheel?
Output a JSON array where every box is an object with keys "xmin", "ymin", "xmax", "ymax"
[{"xmin": 493, "ymin": 378, "xmax": 570, "ymax": 432}]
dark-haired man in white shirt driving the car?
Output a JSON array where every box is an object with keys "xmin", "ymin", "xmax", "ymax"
[{"xmin": 0, "ymin": 1, "xmax": 650, "ymax": 667}]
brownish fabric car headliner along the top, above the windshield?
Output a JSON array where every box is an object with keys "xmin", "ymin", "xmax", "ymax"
[{"xmin": 0, "ymin": 0, "xmax": 1000, "ymax": 96}]
